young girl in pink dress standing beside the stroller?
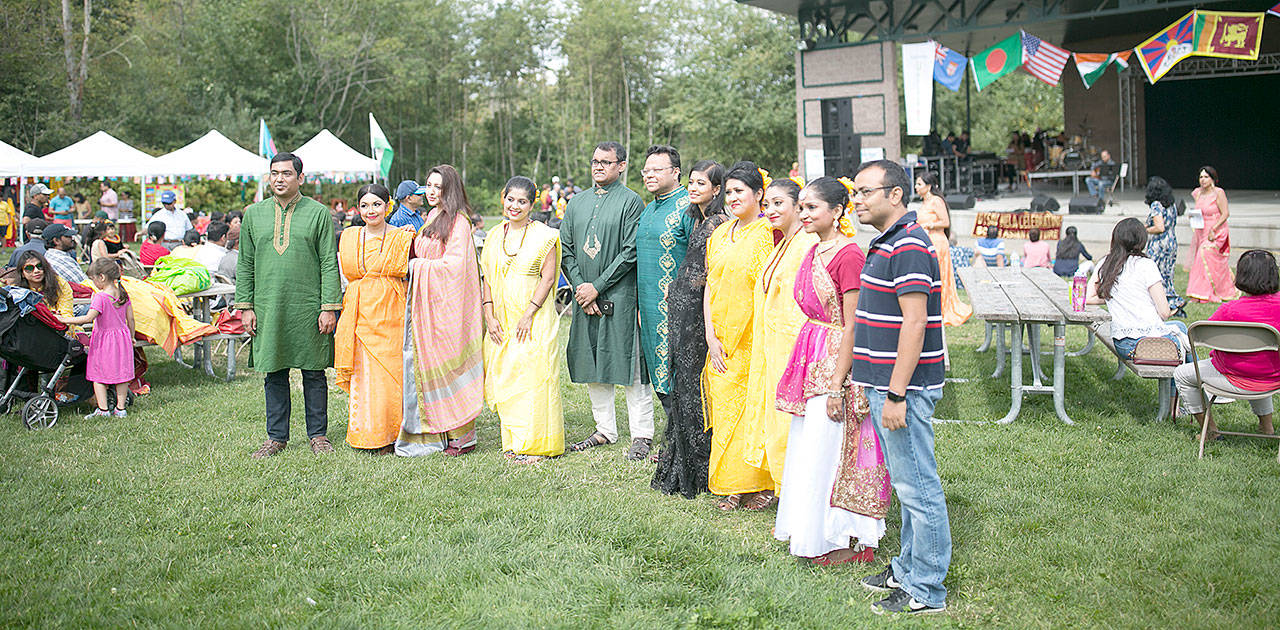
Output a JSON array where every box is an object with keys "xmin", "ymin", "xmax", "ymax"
[{"xmin": 58, "ymin": 257, "xmax": 133, "ymax": 419}]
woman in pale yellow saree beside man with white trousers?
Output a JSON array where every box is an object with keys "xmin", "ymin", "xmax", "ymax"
[{"xmin": 480, "ymin": 177, "xmax": 564, "ymax": 464}]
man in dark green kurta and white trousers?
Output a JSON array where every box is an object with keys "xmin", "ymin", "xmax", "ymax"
[{"xmin": 561, "ymin": 142, "xmax": 653, "ymax": 458}]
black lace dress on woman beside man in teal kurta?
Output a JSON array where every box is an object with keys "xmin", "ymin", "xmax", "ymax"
[{"xmin": 650, "ymin": 214, "xmax": 728, "ymax": 498}]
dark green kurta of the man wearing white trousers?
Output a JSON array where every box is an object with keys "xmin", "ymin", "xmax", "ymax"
[{"xmin": 561, "ymin": 179, "xmax": 649, "ymax": 385}]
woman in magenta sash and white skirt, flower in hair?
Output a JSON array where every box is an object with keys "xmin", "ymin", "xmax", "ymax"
[{"xmin": 773, "ymin": 177, "xmax": 890, "ymax": 565}]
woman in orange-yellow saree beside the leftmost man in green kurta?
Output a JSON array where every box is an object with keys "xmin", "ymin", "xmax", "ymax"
[{"xmin": 333, "ymin": 184, "xmax": 413, "ymax": 453}]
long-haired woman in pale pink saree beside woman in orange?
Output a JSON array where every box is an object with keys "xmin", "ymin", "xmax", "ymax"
[{"xmin": 396, "ymin": 164, "xmax": 484, "ymax": 457}]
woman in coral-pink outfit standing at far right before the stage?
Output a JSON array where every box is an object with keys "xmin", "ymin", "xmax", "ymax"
[{"xmin": 1187, "ymin": 166, "xmax": 1238, "ymax": 302}]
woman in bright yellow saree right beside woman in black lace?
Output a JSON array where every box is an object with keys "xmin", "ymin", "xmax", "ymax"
[{"xmin": 703, "ymin": 161, "xmax": 774, "ymax": 510}]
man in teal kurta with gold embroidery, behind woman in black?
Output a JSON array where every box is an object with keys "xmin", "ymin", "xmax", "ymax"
[{"xmin": 636, "ymin": 145, "xmax": 696, "ymax": 448}]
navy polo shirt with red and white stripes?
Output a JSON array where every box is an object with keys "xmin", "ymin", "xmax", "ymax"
[{"xmin": 850, "ymin": 211, "xmax": 945, "ymax": 391}]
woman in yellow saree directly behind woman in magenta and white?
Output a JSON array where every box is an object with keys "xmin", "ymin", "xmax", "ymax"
[{"xmin": 744, "ymin": 179, "xmax": 818, "ymax": 501}]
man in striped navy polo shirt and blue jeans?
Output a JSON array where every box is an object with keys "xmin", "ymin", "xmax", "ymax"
[{"xmin": 850, "ymin": 160, "xmax": 951, "ymax": 615}]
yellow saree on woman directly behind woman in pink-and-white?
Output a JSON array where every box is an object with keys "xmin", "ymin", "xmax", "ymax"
[{"xmin": 742, "ymin": 230, "xmax": 818, "ymax": 490}]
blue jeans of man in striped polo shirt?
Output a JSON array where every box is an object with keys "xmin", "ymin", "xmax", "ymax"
[{"xmin": 867, "ymin": 387, "xmax": 951, "ymax": 607}]
